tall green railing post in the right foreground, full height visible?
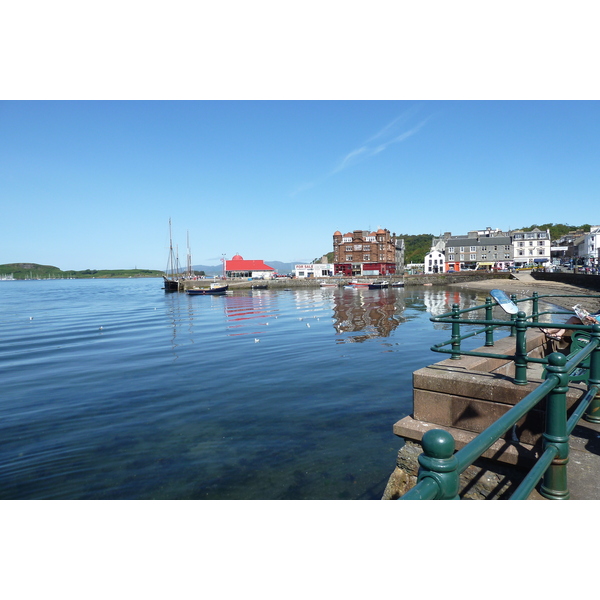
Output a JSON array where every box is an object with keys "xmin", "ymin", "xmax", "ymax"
[{"xmin": 540, "ymin": 352, "xmax": 570, "ymax": 500}]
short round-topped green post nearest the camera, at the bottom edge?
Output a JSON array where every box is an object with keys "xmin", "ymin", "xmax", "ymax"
[{"xmin": 417, "ymin": 429, "xmax": 460, "ymax": 500}]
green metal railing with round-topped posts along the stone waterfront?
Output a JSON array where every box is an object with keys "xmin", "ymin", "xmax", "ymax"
[{"xmin": 400, "ymin": 294, "xmax": 600, "ymax": 500}]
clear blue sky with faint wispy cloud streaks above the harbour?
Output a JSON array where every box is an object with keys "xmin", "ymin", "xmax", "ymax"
[{"xmin": 0, "ymin": 100, "xmax": 600, "ymax": 269}]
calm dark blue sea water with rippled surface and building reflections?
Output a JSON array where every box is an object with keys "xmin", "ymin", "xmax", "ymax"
[{"xmin": 0, "ymin": 279, "xmax": 510, "ymax": 499}]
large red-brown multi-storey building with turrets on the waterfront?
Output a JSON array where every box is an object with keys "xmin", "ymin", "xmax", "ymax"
[{"xmin": 333, "ymin": 229, "xmax": 404, "ymax": 277}]
